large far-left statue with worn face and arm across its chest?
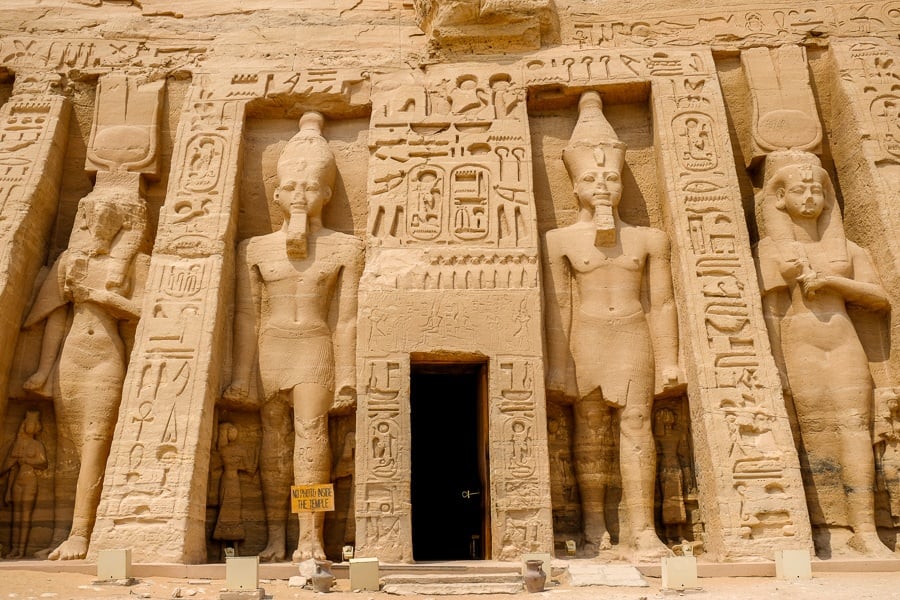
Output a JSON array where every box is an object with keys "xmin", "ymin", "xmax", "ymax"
[{"xmin": 24, "ymin": 180, "xmax": 147, "ymax": 560}]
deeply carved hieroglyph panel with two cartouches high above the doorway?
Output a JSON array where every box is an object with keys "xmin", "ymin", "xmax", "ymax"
[{"xmin": 368, "ymin": 70, "xmax": 536, "ymax": 248}]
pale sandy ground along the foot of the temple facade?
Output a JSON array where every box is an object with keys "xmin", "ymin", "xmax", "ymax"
[{"xmin": 0, "ymin": 570, "xmax": 900, "ymax": 600}]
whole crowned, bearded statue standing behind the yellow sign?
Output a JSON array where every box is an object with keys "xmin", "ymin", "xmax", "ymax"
[{"xmin": 225, "ymin": 112, "xmax": 363, "ymax": 561}]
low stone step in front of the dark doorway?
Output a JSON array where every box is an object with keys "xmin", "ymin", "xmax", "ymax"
[{"xmin": 381, "ymin": 573, "xmax": 524, "ymax": 596}]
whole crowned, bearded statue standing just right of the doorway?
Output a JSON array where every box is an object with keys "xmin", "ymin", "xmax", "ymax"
[{"xmin": 547, "ymin": 92, "xmax": 679, "ymax": 559}]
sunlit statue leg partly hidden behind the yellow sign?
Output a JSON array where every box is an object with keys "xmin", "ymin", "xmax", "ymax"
[{"xmin": 293, "ymin": 383, "xmax": 334, "ymax": 562}]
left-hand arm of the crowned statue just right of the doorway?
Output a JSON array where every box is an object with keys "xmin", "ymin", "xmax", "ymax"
[{"xmin": 544, "ymin": 231, "xmax": 572, "ymax": 396}]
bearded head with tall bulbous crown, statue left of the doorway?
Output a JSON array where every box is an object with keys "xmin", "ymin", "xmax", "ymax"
[{"xmin": 274, "ymin": 112, "xmax": 337, "ymax": 259}]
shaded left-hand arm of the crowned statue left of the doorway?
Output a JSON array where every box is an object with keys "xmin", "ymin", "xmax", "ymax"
[{"xmin": 224, "ymin": 242, "xmax": 260, "ymax": 401}]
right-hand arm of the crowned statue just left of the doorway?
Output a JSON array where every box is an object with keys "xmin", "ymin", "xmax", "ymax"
[{"xmin": 334, "ymin": 238, "xmax": 364, "ymax": 411}]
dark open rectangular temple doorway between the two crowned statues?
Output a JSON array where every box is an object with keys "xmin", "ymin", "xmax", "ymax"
[{"xmin": 410, "ymin": 362, "xmax": 491, "ymax": 561}]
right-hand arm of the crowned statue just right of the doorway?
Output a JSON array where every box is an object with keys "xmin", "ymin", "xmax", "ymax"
[{"xmin": 647, "ymin": 231, "xmax": 682, "ymax": 389}]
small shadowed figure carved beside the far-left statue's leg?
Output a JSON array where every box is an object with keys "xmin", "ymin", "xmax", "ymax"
[{"xmin": 0, "ymin": 410, "xmax": 48, "ymax": 558}]
